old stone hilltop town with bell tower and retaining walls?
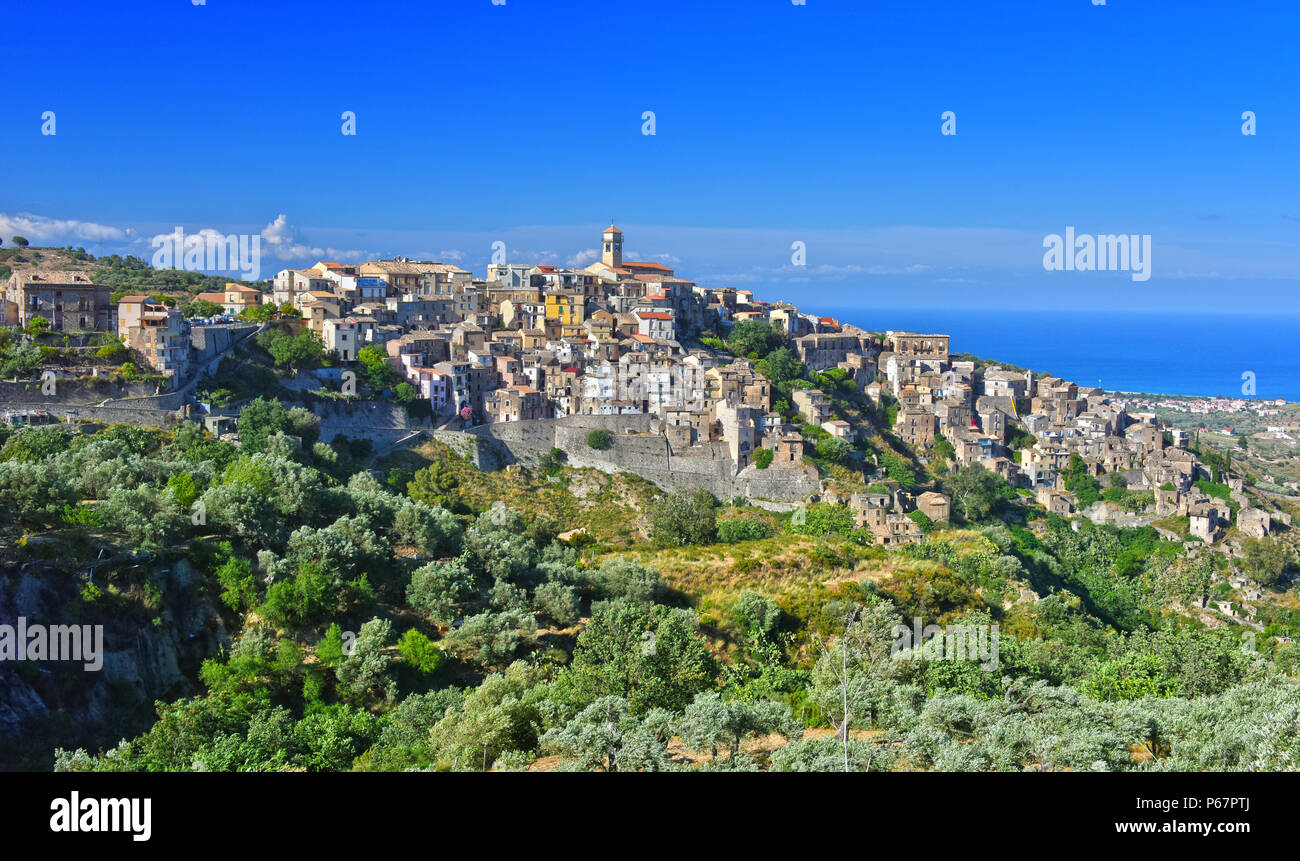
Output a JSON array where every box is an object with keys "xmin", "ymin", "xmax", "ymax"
[{"xmin": 4, "ymin": 225, "xmax": 1290, "ymax": 556}]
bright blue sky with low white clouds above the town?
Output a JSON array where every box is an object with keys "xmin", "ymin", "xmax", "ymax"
[{"xmin": 0, "ymin": 0, "xmax": 1300, "ymax": 312}]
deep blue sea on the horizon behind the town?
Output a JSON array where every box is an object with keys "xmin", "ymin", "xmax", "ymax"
[{"xmin": 816, "ymin": 307, "xmax": 1300, "ymax": 401}]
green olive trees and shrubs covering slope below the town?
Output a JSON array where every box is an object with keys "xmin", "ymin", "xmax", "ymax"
[{"xmin": 0, "ymin": 410, "xmax": 1300, "ymax": 771}]
